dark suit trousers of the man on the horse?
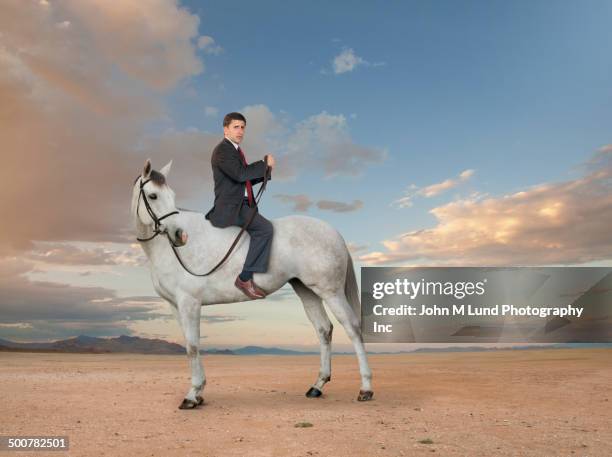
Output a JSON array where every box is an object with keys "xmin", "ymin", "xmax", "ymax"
[{"xmin": 237, "ymin": 197, "xmax": 274, "ymax": 273}]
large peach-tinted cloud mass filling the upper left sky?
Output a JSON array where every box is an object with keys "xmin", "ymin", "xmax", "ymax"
[{"xmin": 0, "ymin": 0, "xmax": 208, "ymax": 255}]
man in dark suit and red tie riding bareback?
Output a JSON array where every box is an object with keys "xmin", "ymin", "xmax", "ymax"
[{"xmin": 206, "ymin": 113, "xmax": 275, "ymax": 298}]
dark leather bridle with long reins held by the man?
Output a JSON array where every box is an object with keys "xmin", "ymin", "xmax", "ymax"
[{"xmin": 134, "ymin": 165, "xmax": 269, "ymax": 277}]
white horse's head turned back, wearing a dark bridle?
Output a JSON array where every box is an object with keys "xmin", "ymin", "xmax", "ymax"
[{"xmin": 132, "ymin": 159, "xmax": 187, "ymax": 246}]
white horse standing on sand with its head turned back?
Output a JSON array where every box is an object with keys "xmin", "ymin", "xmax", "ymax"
[{"xmin": 131, "ymin": 159, "xmax": 373, "ymax": 409}]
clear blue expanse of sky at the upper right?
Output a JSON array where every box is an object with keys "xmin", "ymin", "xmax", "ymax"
[{"xmin": 171, "ymin": 1, "xmax": 612, "ymax": 246}]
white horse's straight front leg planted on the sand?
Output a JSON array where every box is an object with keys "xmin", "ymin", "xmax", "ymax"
[{"xmin": 177, "ymin": 295, "xmax": 206, "ymax": 409}]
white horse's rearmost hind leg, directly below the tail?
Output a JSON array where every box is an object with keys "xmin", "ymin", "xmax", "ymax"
[{"xmin": 323, "ymin": 291, "xmax": 374, "ymax": 401}]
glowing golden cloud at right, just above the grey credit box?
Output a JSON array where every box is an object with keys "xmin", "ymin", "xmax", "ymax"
[{"xmin": 360, "ymin": 151, "xmax": 612, "ymax": 266}]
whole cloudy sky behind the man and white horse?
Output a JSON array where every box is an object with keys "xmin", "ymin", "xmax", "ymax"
[{"xmin": 0, "ymin": 0, "xmax": 612, "ymax": 351}]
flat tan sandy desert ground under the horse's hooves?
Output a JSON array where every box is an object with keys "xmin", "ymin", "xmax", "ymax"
[{"xmin": 0, "ymin": 349, "xmax": 612, "ymax": 457}]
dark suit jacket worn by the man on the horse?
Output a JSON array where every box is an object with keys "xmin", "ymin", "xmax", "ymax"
[{"xmin": 206, "ymin": 138, "xmax": 271, "ymax": 227}]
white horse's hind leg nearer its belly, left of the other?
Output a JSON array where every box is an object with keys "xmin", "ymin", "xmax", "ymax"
[{"xmin": 289, "ymin": 278, "xmax": 333, "ymax": 398}]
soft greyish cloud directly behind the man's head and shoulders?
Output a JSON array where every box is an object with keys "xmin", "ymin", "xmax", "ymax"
[{"xmin": 148, "ymin": 105, "xmax": 387, "ymax": 190}]
